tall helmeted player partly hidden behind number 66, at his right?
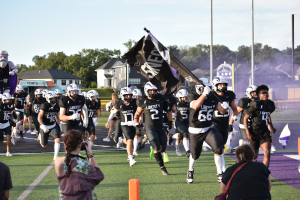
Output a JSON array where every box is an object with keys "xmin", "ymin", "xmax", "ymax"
[{"xmin": 212, "ymin": 76, "xmax": 238, "ymax": 179}]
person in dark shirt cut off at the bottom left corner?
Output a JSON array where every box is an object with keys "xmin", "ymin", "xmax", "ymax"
[{"xmin": 0, "ymin": 162, "xmax": 12, "ymax": 199}]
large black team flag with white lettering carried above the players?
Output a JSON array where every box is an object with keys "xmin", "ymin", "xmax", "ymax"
[{"xmin": 122, "ymin": 32, "xmax": 202, "ymax": 96}]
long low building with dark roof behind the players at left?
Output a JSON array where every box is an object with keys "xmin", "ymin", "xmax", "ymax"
[{"xmin": 18, "ymin": 69, "xmax": 84, "ymax": 93}]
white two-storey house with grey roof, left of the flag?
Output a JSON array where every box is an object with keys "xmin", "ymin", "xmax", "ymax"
[{"xmin": 95, "ymin": 58, "xmax": 125, "ymax": 88}]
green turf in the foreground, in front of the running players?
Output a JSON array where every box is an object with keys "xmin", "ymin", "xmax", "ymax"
[{"xmin": 1, "ymin": 151, "xmax": 300, "ymax": 200}]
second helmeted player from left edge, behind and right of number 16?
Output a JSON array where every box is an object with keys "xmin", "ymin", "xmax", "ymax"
[{"xmin": 12, "ymin": 85, "xmax": 28, "ymax": 138}]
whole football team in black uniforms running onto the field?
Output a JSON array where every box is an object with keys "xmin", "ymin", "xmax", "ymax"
[{"xmin": 0, "ymin": 76, "xmax": 276, "ymax": 184}]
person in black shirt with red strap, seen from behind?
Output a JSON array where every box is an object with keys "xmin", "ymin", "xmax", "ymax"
[{"xmin": 220, "ymin": 145, "xmax": 272, "ymax": 200}]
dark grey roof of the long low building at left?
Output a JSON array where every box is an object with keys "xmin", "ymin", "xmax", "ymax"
[{"xmin": 18, "ymin": 69, "xmax": 82, "ymax": 79}]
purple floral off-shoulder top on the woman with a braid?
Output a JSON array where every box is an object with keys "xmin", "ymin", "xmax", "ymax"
[{"xmin": 56, "ymin": 157, "xmax": 104, "ymax": 200}]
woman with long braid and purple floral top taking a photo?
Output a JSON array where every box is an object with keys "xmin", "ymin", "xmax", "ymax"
[{"xmin": 54, "ymin": 130, "xmax": 104, "ymax": 200}]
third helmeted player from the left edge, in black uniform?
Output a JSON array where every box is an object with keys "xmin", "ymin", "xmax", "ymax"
[{"xmin": 26, "ymin": 89, "xmax": 45, "ymax": 138}]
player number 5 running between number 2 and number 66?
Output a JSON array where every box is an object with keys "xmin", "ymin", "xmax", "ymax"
[{"xmin": 175, "ymin": 89, "xmax": 191, "ymax": 158}]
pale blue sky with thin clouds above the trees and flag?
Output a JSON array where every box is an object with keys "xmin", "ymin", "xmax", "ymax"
[{"xmin": 0, "ymin": 0, "xmax": 300, "ymax": 65}]
